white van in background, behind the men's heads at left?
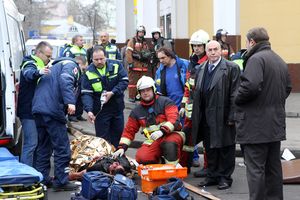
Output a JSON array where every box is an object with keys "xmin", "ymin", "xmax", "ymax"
[{"xmin": 25, "ymin": 38, "xmax": 71, "ymax": 59}]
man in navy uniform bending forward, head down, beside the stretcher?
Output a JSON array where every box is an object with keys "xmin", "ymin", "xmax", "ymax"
[{"xmin": 32, "ymin": 58, "xmax": 80, "ymax": 191}]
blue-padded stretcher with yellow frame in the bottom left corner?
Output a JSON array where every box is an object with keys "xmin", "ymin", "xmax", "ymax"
[{"xmin": 0, "ymin": 147, "xmax": 47, "ymax": 200}]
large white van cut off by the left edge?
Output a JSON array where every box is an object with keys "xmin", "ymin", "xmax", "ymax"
[{"xmin": 0, "ymin": 0, "xmax": 25, "ymax": 154}]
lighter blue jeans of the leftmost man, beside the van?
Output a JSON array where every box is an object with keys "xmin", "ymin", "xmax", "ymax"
[{"xmin": 21, "ymin": 119, "xmax": 38, "ymax": 167}]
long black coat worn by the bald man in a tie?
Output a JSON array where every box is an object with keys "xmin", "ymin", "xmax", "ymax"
[{"xmin": 192, "ymin": 58, "xmax": 240, "ymax": 148}]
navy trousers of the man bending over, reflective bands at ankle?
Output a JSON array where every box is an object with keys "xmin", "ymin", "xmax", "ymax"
[{"xmin": 35, "ymin": 115, "xmax": 71, "ymax": 186}]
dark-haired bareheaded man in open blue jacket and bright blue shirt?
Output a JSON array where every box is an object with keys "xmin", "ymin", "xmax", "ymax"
[{"xmin": 155, "ymin": 47, "xmax": 189, "ymax": 109}]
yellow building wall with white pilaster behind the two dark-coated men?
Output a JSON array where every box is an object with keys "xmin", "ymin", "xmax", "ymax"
[{"xmin": 189, "ymin": 0, "xmax": 300, "ymax": 92}]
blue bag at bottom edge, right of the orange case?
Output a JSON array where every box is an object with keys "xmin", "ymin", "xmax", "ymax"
[{"xmin": 149, "ymin": 178, "xmax": 194, "ymax": 200}]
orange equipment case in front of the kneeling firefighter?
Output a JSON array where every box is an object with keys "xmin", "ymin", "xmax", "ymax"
[{"xmin": 138, "ymin": 164, "xmax": 187, "ymax": 193}]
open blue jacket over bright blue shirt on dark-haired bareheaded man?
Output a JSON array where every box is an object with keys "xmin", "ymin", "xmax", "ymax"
[{"xmin": 155, "ymin": 57, "xmax": 189, "ymax": 106}]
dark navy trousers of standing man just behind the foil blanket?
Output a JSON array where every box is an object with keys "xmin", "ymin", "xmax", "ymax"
[{"xmin": 95, "ymin": 111, "xmax": 124, "ymax": 147}]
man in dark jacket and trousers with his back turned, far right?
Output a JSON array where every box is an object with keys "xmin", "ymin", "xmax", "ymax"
[{"xmin": 235, "ymin": 27, "xmax": 292, "ymax": 200}]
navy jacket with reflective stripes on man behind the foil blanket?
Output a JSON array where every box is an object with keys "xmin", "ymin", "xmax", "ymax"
[{"xmin": 81, "ymin": 59, "xmax": 128, "ymax": 115}]
